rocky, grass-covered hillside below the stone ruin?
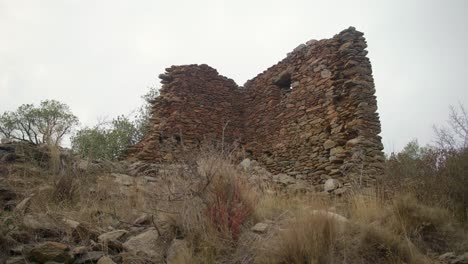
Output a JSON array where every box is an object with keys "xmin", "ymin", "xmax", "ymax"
[{"xmin": 0, "ymin": 143, "xmax": 468, "ymax": 264}]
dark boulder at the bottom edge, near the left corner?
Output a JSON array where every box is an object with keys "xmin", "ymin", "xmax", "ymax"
[{"xmin": 28, "ymin": 242, "xmax": 72, "ymax": 263}]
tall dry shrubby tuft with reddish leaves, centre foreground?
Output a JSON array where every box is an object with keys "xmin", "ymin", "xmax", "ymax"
[{"xmin": 169, "ymin": 150, "xmax": 258, "ymax": 263}]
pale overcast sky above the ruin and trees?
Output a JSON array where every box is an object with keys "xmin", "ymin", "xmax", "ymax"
[{"xmin": 0, "ymin": 0, "xmax": 468, "ymax": 152}]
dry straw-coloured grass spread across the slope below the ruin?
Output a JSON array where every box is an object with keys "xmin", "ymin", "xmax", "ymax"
[{"xmin": 0, "ymin": 145, "xmax": 468, "ymax": 264}]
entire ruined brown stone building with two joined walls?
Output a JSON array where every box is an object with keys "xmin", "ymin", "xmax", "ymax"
[{"xmin": 129, "ymin": 27, "xmax": 384, "ymax": 186}]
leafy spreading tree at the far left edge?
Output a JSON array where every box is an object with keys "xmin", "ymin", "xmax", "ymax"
[{"xmin": 0, "ymin": 100, "xmax": 78, "ymax": 145}]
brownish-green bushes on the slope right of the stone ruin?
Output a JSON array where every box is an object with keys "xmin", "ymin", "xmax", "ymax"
[{"xmin": 381, "ymin": 106, "xmax": 468, "ymax": 222}]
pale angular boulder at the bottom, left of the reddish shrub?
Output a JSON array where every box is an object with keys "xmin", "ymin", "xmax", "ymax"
[{"xmin": 122, "ymin": 228, "xmax": 162, "ymax": 259}]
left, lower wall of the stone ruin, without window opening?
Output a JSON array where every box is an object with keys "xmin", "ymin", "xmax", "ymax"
[{"xmin": 130, "ymin": 64, "xmax": 243, "ymax": 162}]
